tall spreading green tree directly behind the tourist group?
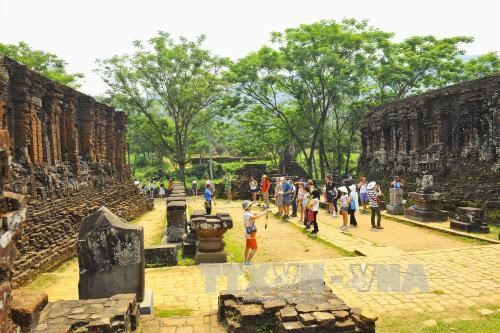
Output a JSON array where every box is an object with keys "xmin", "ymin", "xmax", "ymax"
[{"xmin": 233, "ymin": 19, "xmax": 391, "ymax": 176}]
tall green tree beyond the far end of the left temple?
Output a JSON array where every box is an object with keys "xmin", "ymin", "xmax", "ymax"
[{"xmin": 98, "ymin": 32, "xmax": 229, "ymax": 181}]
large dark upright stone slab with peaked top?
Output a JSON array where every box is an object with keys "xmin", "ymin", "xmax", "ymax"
[{"xmin": 77, "ymin": 207, "xmax": 144, "ymax": 302}]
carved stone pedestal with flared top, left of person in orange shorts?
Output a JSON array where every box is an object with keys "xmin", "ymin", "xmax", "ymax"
[{"xmin": 191, "ymin": 215, "xmax": 233, "ymax": 264}]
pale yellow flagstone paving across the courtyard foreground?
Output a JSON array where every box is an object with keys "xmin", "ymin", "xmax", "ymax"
[{"xmin": 19, "ymin": 197, "xmax": 500, "ymax": 333}]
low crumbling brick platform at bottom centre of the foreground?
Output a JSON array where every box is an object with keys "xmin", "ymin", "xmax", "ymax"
[{"xmin": 219, "ymin": 288, "xmax": 378, "ymax": 333}]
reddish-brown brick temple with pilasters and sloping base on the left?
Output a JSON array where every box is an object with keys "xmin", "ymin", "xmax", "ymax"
[{"xmin": 0, "ymin": 56, "xmax": 147, "ymax": 286}]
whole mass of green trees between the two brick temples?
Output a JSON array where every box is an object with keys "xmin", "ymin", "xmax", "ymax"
[{"xmin": 98, "ymin": 19, "xmax": 500, "ymax": 179}]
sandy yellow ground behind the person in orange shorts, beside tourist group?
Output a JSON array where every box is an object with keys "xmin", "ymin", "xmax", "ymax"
[{"xmin": 189, "ymin": 198, "xmax": 343, "ymax": 263}]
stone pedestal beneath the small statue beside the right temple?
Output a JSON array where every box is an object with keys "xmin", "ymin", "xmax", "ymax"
[{"xmin": 405, "ymin": 192, "xmax": 448, "ymax": 222}]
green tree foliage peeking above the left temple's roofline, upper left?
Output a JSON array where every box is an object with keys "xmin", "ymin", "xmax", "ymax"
[{"xmin": 0, "ymin": 42, "xmax": 83, "ymax": 89}]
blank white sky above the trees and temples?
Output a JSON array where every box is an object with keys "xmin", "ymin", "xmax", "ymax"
[{"xmin": 0, "ymin": 0, "xmax": 500, "ymax": 95}]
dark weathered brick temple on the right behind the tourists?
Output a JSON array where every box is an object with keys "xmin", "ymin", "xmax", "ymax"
[{"xmin": 359, "ymin": 74, "xmax": 500, "ymax": 217}]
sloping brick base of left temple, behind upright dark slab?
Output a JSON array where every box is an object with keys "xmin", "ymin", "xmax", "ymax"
[{"xmin": 13, "ymin": 183, "xmax": 148, "ymax": 287}]
